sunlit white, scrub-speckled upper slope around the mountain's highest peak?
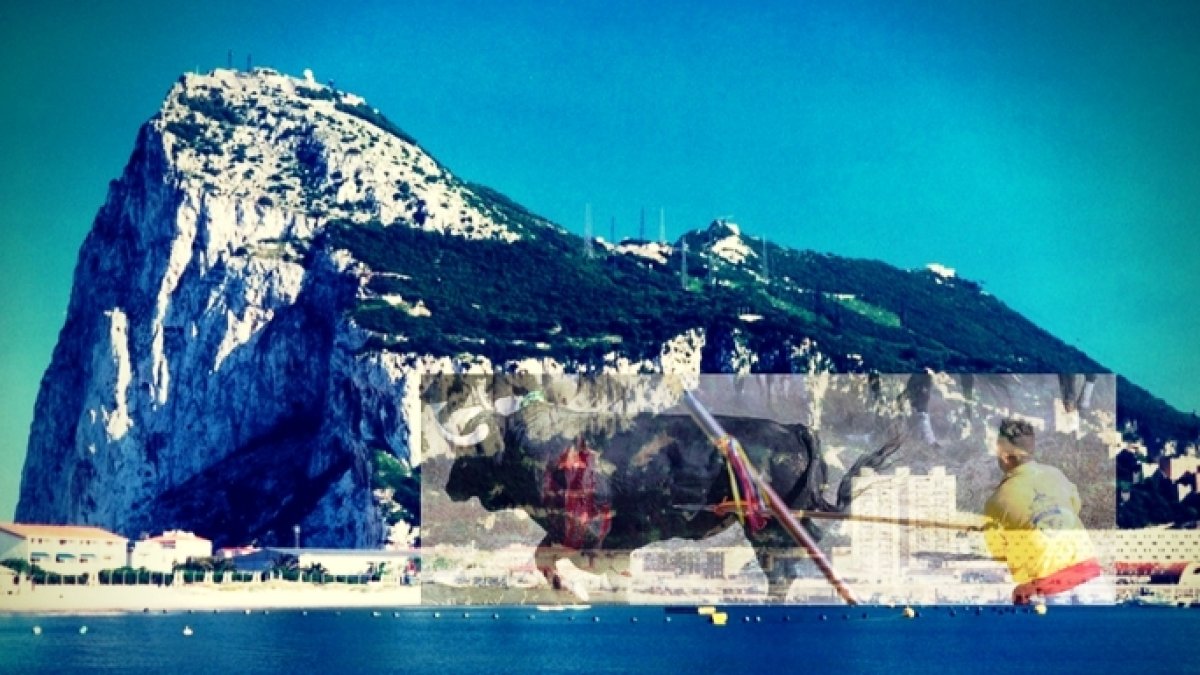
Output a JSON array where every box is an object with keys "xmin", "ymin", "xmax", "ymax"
[{"xmin": 158, "ymin": 70, "xmax": 520, "ymax": 240}]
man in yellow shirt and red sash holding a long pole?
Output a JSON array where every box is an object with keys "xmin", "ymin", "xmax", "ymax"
[{"xmin": 984, "ymin": 419, "xmax": 1115, "ymax": 604}]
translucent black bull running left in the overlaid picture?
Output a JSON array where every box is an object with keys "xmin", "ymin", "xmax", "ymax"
[{"xmin": 446, "ymin": 414, "xmax": 900, "ymax": 590}]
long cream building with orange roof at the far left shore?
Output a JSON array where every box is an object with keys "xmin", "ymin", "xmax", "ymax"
[{"xmin": 0, "ymin": 522, "xmax": 128, "ymax": 574}]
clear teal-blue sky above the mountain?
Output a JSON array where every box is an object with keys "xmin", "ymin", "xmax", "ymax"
[{"xmin": 0, "ymin": 0, "xmax": 1200, "ymax": 519}]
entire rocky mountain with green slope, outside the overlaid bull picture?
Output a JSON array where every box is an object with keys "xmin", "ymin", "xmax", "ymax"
[{"xmin": 17, "ymin": 68, "xmax": 1184, "ymax": 546}]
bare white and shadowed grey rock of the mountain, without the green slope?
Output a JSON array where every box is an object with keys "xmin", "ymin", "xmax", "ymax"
[{"xmin": 17, "ymin": 70, "xmax": 792, "ymax": 546}]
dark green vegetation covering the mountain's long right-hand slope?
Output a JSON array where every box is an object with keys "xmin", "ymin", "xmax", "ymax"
[{"xmin": 316, "ymin": 185, "xmax": 1198, "ymax": 449}]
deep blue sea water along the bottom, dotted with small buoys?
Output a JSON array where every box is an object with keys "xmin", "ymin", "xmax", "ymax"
[{"xmin": 0, "ymin": 607, "xmax": 1200, "ymax": 675}]
